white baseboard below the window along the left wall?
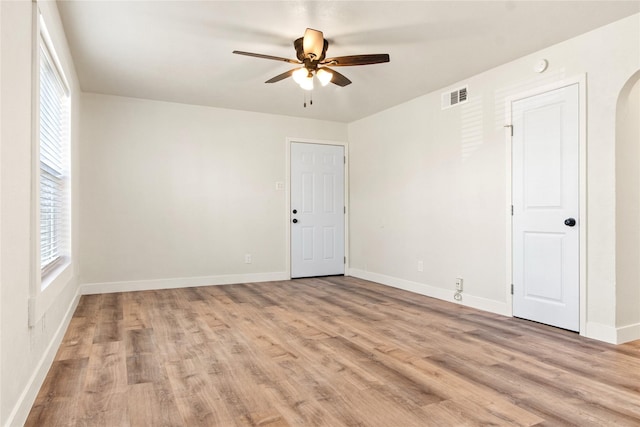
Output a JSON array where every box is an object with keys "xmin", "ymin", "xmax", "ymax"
[{"xmin": 5, "ymin": 288, "xmax": 80, "ymax": 426}]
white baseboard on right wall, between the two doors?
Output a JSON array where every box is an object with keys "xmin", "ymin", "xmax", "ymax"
[{"xmin": 348, "ymin": 268, "xmax": 510, "ymax": 316}]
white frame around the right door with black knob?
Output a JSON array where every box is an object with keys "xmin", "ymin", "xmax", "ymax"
[{"xmin": 505, "ymin": 74, "xmax": 588, "ymax": 336}]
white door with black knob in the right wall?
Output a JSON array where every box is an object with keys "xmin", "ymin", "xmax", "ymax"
[{"xmin": 511, "ymin": 84, "xmax": 580, "ymax": 331}]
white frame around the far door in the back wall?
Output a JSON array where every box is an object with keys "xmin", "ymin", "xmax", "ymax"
[{"xmin": 284, "ymin": 137, "xmax": 349, "ymax": 280}]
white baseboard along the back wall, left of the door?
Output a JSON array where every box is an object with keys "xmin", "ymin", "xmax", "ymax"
[{"xmin": 80, "ymin": 272, "xmax": 290, "ymax": 295}]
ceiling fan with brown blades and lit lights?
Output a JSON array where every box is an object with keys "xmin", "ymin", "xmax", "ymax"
[{"xmin": 233, "ymin": 28, "xmax": 389, "ymax": 90}]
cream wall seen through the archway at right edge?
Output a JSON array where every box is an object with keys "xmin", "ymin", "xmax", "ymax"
[{"xmin": 616, "ymin": 71, "xmax": 640, "ymax": 331}]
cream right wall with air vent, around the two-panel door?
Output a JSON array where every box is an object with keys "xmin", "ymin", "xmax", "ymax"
[{"xmin": 349, "ymin": 15, "xmax": 640, "ymax": 342}]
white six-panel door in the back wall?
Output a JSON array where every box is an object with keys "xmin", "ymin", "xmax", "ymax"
[{"xmin": 290, "ymin": 142, "xmax": 345, "ymax": 278}]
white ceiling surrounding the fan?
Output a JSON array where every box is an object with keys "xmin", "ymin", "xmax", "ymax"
[{"xmin": 58, "ymin": 0, "xmax": 640, "ymax": 122}]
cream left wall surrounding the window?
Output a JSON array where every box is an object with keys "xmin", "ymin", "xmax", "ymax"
[{"xmin": 0, "ymin": 1, "xmax": 80, "ymax": 425}]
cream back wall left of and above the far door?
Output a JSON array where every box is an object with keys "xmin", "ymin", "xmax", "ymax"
[{"xmin": 80, "ymin": 94, "xmax": 347, "ymax": 292}]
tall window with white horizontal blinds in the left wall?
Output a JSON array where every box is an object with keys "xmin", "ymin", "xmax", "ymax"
[{"xmin": 39, "ymin": 20, "xmax": 70, "ymax": 277}]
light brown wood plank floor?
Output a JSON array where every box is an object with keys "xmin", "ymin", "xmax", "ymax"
[{"xmin": 27, "ymin": 277, "xmax": 640, "ymax": 427}]
